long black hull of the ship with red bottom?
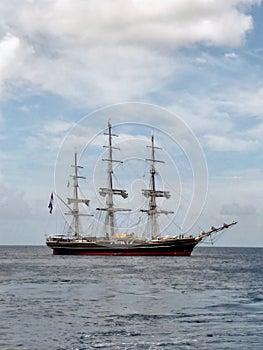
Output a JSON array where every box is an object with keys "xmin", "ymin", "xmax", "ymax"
[{"xmin": 47, "ymin": 239, "xmax": 199, "ymax": 256}]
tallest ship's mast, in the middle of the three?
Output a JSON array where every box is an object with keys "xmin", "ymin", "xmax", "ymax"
[{"xmin": 97, "ymin": 122, "xmax": 131, "ymax": 239}]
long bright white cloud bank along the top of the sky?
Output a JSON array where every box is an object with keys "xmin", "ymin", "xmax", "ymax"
[{"xmin": 11, "ymin": 0, "xmax": 258, "ymax": 48}]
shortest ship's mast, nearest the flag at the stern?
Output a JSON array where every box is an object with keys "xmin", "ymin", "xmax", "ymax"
[{"xmin": 65, "ymin": 152, "xmax": 92, "ymax": 239}]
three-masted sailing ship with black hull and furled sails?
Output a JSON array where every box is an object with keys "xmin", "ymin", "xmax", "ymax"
[{"xmin": 46, "ymin": 123, "xmax": 237, "ymax": 256}]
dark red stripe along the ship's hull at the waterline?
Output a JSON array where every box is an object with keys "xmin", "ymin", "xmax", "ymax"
[{"xmin": 53, "ymin": 250, "xmax": 191, "ymax": 256}]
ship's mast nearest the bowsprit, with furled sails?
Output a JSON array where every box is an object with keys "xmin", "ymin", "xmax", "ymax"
[{"xmin": 141, "ymin": 135, "xmax": 173, "ymax": 239}]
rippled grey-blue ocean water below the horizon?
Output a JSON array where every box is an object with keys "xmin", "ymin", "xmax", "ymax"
[{"xmin": 0, "ymin": 246, "xmax": 263, "ymax": 350}]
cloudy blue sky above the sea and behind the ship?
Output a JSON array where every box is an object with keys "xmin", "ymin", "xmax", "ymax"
[{"xmin": 0, "ymin": 0, "xmax": 263, "ymax": 247}]
